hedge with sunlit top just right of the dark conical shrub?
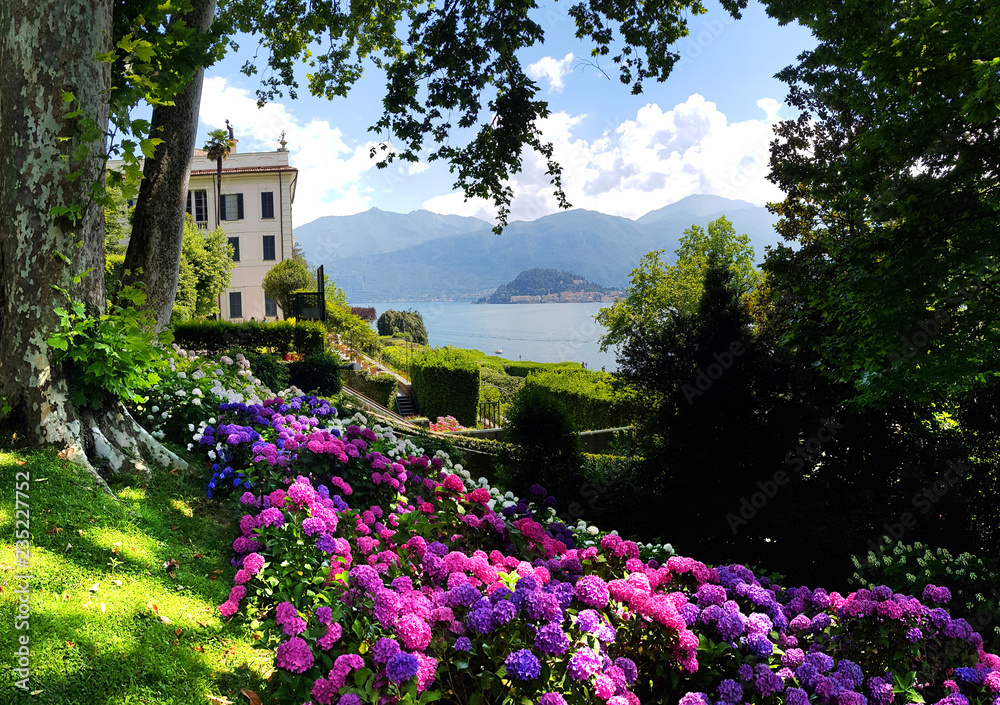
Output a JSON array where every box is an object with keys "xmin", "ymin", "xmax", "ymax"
[{"xmin": 525, "ymin": 370, "xmax": 634, "ymax": 431}]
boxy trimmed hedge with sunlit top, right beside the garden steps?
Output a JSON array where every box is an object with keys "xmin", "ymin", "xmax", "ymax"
[{"xmin": 410, "ymin": 348, "xmax": 479, "ymax": 428}]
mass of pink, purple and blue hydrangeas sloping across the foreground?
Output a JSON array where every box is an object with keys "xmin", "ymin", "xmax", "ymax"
[{"xmin": 186, "ymin": 390, "xmax": 1000, "ymax": 705}]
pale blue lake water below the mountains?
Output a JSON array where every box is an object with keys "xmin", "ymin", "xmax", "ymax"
[{"xmin": 351, "ymin": 301, "xmax": 618, "ymax": 372}]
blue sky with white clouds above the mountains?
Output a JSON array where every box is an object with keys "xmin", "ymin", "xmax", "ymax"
[{"xmin": 193, "ymin": 2, "xmax": 814, "ymax": 226}]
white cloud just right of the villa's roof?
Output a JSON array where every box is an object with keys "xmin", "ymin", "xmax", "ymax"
[{"xmin": 199, "ymin": 77, "xmax": 388, "ymax": 225}]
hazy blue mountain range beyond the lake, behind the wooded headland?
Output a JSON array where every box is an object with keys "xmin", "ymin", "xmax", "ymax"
[{"xmin": 295, "ymin": 195, "xmax": 780, "ymax": 302}]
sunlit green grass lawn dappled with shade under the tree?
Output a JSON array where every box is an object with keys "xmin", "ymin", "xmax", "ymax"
[{"xmin": 0, "ymin": 451, "xmax": 272, "ymax": 705}]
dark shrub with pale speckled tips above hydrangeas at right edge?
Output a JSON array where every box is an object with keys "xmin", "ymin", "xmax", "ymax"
[{"xmin": 852, "ymin": 542, "xmax": 1000, "ymax": 653}]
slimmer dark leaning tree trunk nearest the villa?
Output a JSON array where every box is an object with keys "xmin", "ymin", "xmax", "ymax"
[{"xmin": 121, "ymin": 0, "xmax": 216, "ymax": 330}]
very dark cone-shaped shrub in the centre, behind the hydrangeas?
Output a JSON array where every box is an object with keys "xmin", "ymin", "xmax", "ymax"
[{"xmin": 497, "ymin": 386, "xmax": 583, "ymax": 506}]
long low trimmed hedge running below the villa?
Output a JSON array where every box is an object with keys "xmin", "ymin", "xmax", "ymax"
[{"xmin": 174, "ymin": 321, "xmax": 326, "ymax": 356}]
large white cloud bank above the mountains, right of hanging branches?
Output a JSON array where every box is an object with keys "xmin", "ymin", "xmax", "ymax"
[{"xmin": 424, "ymin": 94, "xmax": 781, "ymax": 220}]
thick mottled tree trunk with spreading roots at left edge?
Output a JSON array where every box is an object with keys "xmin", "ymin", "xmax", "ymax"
[{"xmin": 0, "ymin": 0, "xmax": 183, "ymax": 482}]
